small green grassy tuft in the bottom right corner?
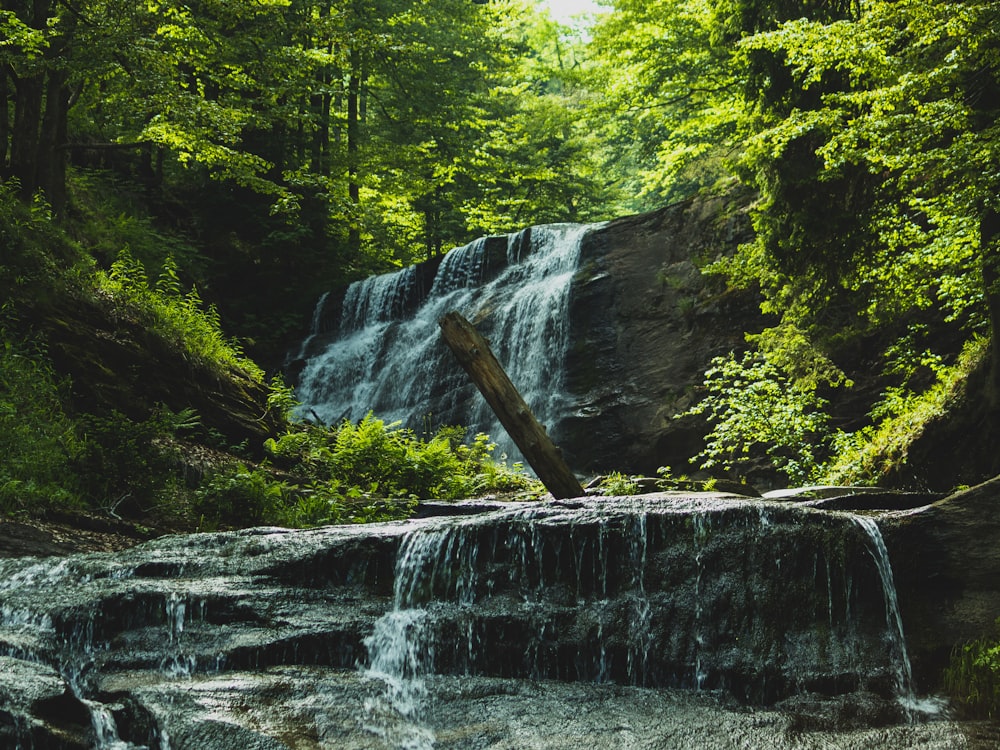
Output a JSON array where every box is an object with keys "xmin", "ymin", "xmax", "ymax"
[{"xmin": 944, "ymin": 622, "xmax": 1000, "ymax": 719}]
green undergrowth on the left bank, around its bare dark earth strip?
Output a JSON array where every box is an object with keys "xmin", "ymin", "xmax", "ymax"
[{"xmin": 0, "ymin": 183, "xmax": 541, "ymax": 529}]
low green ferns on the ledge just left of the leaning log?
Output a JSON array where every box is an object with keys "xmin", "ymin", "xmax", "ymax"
[{"xmin": 193, "ymin": 414, "xmax": 539, "ymax": 528}]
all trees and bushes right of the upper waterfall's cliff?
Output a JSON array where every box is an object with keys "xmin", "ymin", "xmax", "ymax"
[{"xmin": 594, "ymin": 0, "xmax": 1000, "ymax": 494}]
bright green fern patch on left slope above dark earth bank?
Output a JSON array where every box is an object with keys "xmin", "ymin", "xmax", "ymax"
[{"xmin": 96, "ymin": 248, "xmax": 264, "ymax": 382}]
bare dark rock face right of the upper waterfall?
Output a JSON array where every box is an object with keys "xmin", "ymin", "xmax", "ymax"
[{"xmin": 557, "ymin": 192, "xmax": 764, "ymax": 474}]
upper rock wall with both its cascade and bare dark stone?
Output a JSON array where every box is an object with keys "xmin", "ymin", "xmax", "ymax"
[{"xmin": 290, "ymin": 188, "xmax": 762, "ymax": 474}]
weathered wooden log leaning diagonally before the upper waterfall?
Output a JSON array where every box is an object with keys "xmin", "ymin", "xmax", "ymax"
[{"xmin": 438, "ymin": 312, "xmax": 585, "ymax": 499}]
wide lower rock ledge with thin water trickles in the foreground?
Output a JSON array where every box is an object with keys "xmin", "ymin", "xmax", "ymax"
[{"xmin": 0, "ymin": 494, "xmax": 988, "ymax": 750}]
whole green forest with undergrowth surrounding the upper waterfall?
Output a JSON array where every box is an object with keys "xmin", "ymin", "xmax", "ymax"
[{"xmin": 0, "ymin": 0, "xmax": 1000, "ymax": 525}]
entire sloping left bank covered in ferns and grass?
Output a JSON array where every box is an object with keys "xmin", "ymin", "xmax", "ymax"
[{"xmin": 0, "ymin": 183, "xmax": 535, "ymax": 529}]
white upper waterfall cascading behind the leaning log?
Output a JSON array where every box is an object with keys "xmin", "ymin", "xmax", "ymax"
[{"xmin": 297, "ymin": 224, "xmax": 591, "ymax": 453}]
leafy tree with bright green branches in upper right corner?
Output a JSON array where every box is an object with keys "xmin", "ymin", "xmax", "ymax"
[{"xmin": 742, "ymin": 0, "xmax": 1000, "ymax": 384}]
